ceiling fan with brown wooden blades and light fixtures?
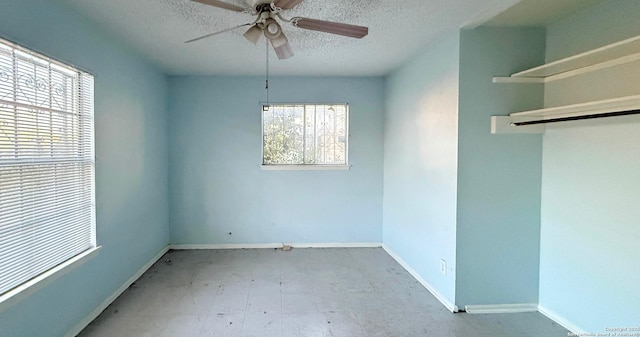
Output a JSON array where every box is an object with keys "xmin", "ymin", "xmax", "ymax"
[{"xmin": 185, "ymin": 0, "xmax": 369, "ymax": 59}]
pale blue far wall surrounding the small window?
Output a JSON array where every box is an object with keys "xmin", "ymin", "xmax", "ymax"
[{"xmin": 169, "ymin": 77, "xmax": 384, "ymax": 244}]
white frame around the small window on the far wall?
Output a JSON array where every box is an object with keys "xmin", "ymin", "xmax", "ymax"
[{"xmin": 260, "ymin": 102, "xmax": 351, "ymax": 171}]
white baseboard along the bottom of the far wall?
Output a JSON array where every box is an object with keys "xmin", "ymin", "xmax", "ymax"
[{"xmin": 169, "ymin": 242, "xmax": 382, "ymax": 250}]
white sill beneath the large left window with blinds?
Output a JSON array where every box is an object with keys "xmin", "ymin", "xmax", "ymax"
[{"xmin": 0, "ymin": 246, "xmax": 101, "ymax": 312}]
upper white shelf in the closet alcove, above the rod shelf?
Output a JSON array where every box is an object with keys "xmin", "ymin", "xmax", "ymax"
[{"xmin": 493, "ymin": 36, "xmax": 640, "ymax": 83}]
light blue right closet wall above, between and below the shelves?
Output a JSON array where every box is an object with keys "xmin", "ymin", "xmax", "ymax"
[{"xmin": 540, "ymin": 0, "xmax": 640, "ymax": 334}]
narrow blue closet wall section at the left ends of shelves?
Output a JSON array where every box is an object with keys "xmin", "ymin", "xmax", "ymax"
[{"xmin": 456, "ymin": 28, "xmax": 545, "ymax": 307}]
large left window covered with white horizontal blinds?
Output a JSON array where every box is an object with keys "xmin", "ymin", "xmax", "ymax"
[{"xmin": 0, "ymin": 39, "xmax": 95, "ymax": 295}]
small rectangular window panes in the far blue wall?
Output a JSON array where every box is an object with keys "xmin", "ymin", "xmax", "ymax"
[{"xmin": 262, "ymin": 104, "xmax": 349, "ymax": 167}]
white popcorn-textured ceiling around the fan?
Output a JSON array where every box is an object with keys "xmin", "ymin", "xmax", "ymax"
[{"xmin": 59, "ymin": 0, "xmax": 518, "ymax": 76}]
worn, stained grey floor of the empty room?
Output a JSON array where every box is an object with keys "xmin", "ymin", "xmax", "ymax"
[{"xmin": 79, "ymin": 248, "xmax": 568, "ymax": 337}]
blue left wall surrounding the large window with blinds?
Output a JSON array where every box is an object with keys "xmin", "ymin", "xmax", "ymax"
[{"xmin": 0, "ymin": 0, "xmax": 169, "ymax": 337}]
